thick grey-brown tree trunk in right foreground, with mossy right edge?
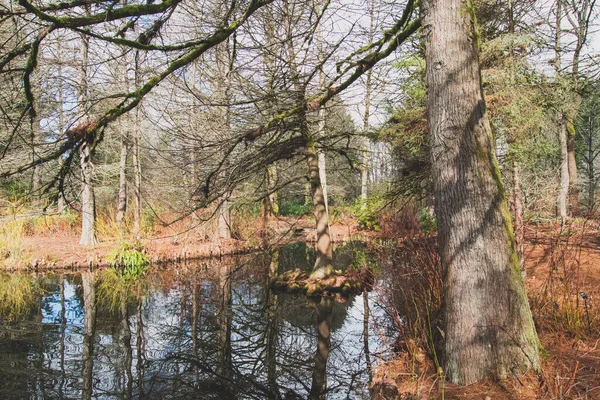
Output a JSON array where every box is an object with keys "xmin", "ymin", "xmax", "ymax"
[{"xmin": 423, "ymin": 0, "xmax": 540, "ymax": 385}]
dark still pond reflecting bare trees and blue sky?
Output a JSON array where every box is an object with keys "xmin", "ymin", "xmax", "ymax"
[{"xmin": 0, "ymin": 245, "xmax": 391, "ymax": 399}]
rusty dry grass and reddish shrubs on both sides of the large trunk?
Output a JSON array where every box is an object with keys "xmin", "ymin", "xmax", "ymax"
[{"xmin": 375, "ymin": 221, "xmax": 600, "ymax": 400}]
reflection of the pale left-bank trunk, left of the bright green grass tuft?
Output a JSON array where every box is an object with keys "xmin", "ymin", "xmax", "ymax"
[{"xmin": 81, "ymin": 272, "xmax": 96, "ymax": 399}]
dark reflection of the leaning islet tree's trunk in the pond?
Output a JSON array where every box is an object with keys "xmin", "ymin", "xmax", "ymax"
[{"xmin": 308, "ymin": 297, "xmax": 333, "ymax": 400}]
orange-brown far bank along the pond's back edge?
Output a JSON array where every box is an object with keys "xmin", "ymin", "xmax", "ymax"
[{"xmin": 0, "ymin": 218, "xmax": 374, "ymax": 271}]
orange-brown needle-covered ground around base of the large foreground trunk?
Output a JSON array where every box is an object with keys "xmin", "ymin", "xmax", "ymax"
[{"xmin": 373, "ymin": 221, "xmax": 600, "ymax": 400}]
